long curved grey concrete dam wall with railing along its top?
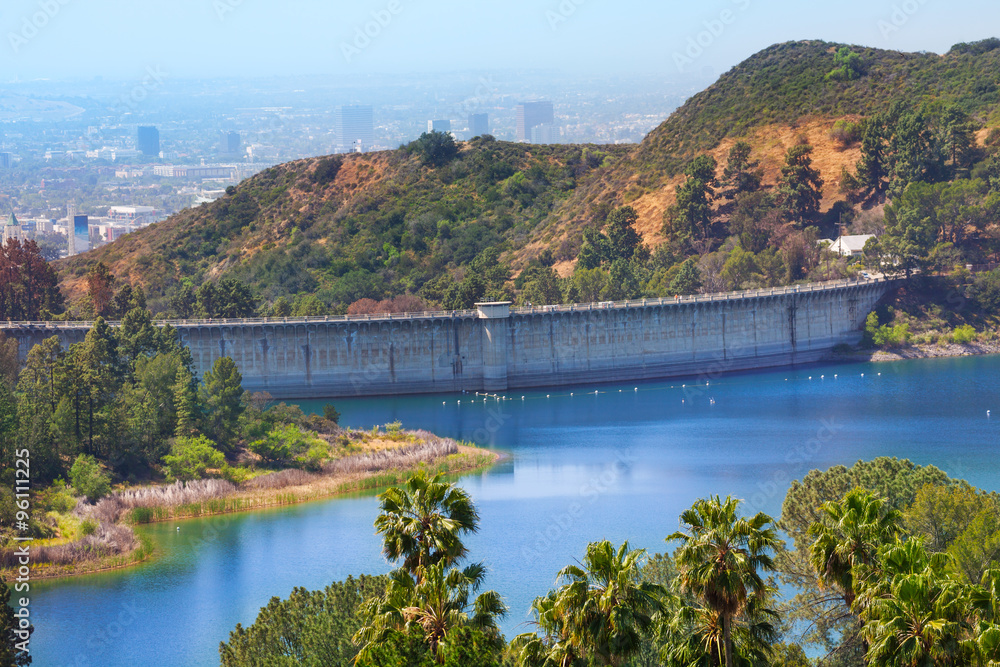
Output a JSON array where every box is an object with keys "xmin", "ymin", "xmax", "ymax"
[{"xmin": 0, "ymin": 279, "xmax": 891, "ymax": 399}]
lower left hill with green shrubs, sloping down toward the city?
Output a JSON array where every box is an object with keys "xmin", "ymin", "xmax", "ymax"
[{"xmin": 59, "ymin": 140, "xmax": 628, "ymax": 304}]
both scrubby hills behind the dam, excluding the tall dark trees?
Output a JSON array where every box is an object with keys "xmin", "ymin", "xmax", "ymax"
[{"xmin": 58, "ymin": 40, "xmax": 1000, "ymax": 311}]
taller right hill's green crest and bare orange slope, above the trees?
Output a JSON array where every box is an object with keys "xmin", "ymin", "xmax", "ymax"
[{"xmin": 551, "ymin": 40, "xmax": 1000, "ymax": 258}]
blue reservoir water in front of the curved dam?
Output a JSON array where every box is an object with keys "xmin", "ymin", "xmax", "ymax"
[{"xmin": 31, "ymin": 357, "xmax": 1000, "ymax": 667}]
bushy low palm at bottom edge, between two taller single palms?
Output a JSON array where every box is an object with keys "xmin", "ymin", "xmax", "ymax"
[{"xmin": 511, "ymin": 540, "xmax": 664, "ymax": 667}]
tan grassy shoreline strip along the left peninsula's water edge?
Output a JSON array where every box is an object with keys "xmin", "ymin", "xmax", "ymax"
[{"xmin": 9, "ymin": 445, "xmax": 500, "ymax": 581}]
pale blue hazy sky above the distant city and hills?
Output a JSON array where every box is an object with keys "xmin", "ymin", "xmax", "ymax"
[{"xmin": 0, "ymin": 0, "xmax": 1000, "ymax": 82}]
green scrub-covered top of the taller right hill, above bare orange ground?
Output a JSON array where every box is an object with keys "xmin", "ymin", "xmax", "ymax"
[{"xmin": 632, "ymin": 40, "xmax": 1000, "ymax": 175}]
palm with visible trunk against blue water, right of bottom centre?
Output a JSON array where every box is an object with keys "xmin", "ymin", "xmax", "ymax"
[{"xmin": 667, "ymin": 496, "xmax": 778, "ymax": 667}]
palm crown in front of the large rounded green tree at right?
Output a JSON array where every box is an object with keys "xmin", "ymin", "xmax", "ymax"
[{"xmin": 809, "ymin": 489, "xmax": 902, "ymax": 608}]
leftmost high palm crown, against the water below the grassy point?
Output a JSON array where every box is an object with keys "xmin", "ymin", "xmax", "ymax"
[{"xmin": 375, "ymin": 471, "xmax": 479, "ymax": 574}]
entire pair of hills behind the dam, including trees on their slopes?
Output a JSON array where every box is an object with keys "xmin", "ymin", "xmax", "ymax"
[{"xmin": 58, "ymin": 39, "xmax": 1000, "ymax": 317}]
